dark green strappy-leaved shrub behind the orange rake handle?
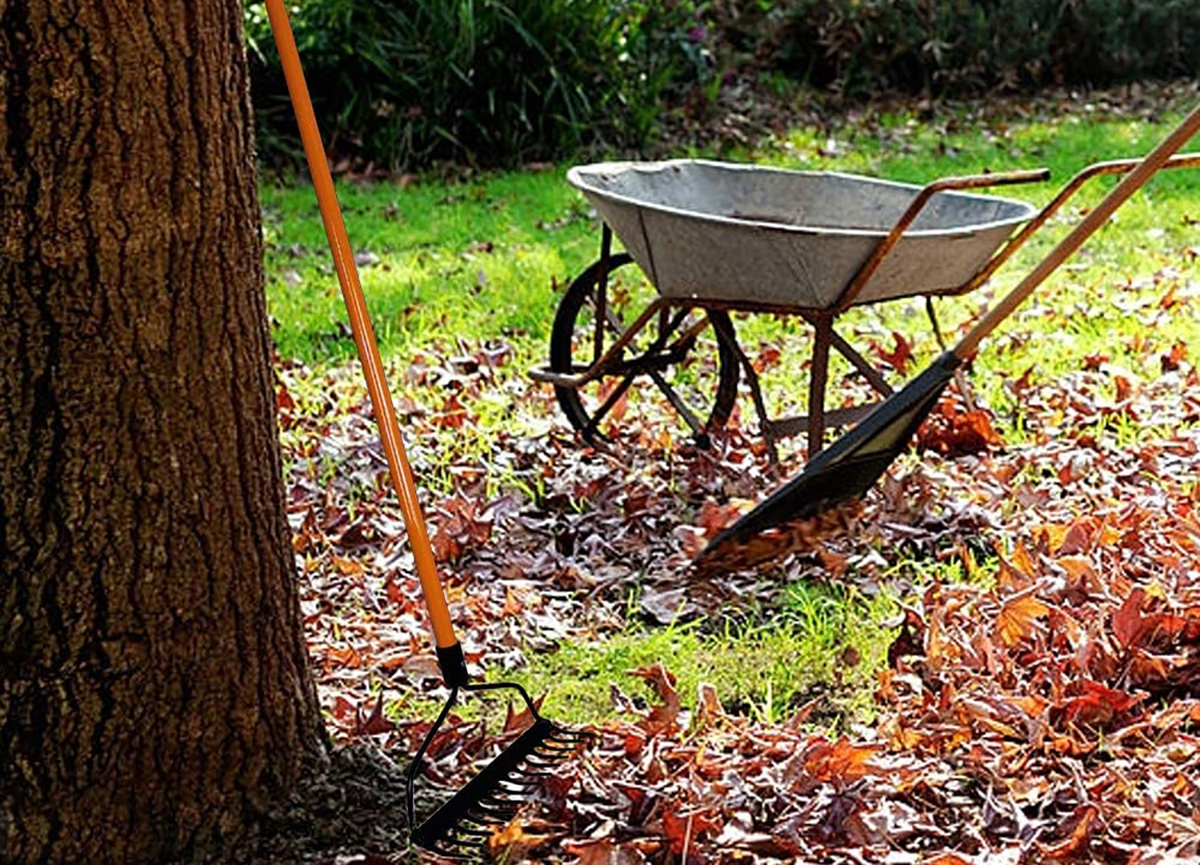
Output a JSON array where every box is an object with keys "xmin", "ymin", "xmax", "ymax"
[{"xmin": 246, "ymin": 0, "xmax": 698, "ymax": 168}]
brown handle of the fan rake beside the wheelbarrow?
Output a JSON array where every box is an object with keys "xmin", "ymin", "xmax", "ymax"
[{"xmin": 950, "ymin": 104, "xmax": 1200, "ymax": 360}]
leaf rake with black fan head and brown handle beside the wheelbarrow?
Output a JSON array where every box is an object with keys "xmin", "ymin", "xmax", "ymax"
[{"xmin": 694, "ymin": 99, "xmax": 1200, "ymax": 569}]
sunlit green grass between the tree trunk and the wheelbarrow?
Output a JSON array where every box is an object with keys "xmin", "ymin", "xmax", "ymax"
[{"xmin": 262, "ymin": 172, "xmax": 595, "ymax": 362}]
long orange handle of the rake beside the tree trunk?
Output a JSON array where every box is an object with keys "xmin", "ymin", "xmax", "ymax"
[{"xmin": 266, "ymin": 0, "xmax": 458, "ymax": 657}]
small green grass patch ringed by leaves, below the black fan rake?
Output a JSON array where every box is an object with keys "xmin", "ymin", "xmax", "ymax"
[{"xmin": 508, "ymin": 584, "xmax": 896, "ymax": 731}]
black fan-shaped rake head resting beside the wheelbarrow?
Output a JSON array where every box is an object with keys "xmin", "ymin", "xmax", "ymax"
[{"xmin": 694, "ymin": 352, "xmax": 962, "ymax": 567}]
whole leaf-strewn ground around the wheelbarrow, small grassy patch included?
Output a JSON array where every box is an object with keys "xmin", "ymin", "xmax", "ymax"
[{"xmin": 258, "ymin": 85, "xmax": 1200, "ymax": 865}]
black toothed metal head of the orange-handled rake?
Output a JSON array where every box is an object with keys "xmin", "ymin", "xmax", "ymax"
[{"xmin": 408, "ymin": 683, "xmax": 589, "ymax": 859}]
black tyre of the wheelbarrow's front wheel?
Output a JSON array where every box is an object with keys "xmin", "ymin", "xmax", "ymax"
[{"xmin": 550, "ymin": 252, "xmax": 740, "ymax": 446}]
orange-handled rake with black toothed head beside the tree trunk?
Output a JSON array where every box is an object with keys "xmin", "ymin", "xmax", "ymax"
[{"xmin": 266, "ymin": 0, "xmax": 588, "ymax": 859}]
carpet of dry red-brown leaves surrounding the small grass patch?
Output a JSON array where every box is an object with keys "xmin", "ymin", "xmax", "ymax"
[{"xmin": 280, "ymin": 257, "xmax": 1200, "ymax": 865}]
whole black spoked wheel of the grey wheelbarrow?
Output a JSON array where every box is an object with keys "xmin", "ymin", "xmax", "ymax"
[{"xmin": 550, "ymin": 253, "xmax": 739, "ymax": 447}]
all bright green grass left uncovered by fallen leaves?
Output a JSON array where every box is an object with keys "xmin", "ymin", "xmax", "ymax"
[{"xmin": 272, "ymin": 101, "xmax": 1200, "ymax": 728}]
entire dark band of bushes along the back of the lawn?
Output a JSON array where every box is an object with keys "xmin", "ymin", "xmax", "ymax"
[{"xmin": 246, "ymin": 0, "xmax": 1200, "ymax": 170}]
